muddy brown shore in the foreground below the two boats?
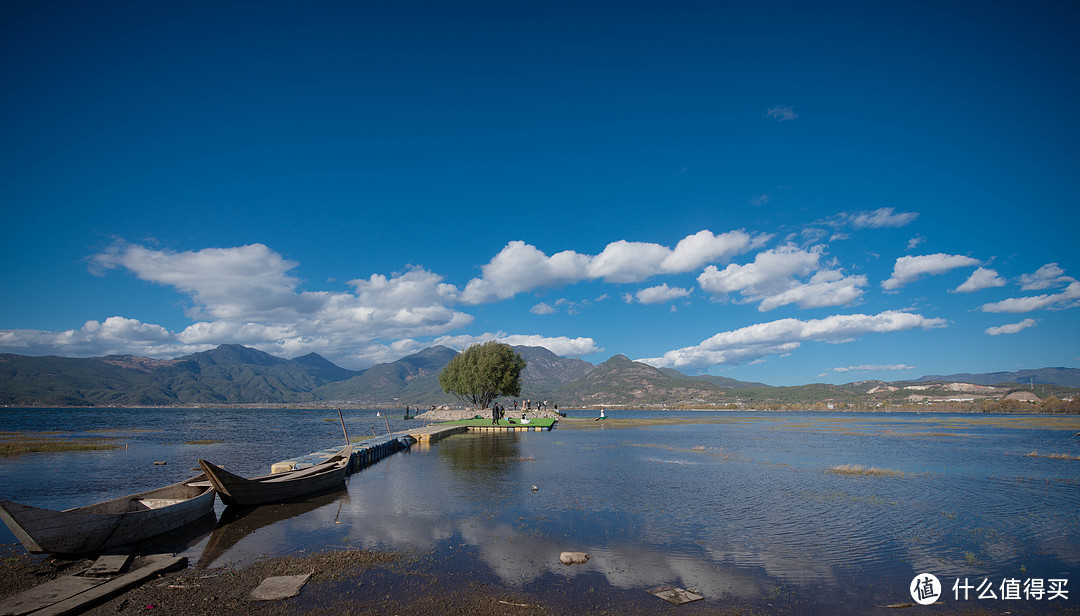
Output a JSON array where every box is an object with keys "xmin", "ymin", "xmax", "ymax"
[{"xmin": 0, "ymin": 546, "xmax": 774, "ymax": 616}]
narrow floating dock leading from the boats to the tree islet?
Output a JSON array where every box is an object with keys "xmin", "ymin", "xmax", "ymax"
[{"xmin": 270, "ymin": 419, "xmax": 556, "ymax": 473}]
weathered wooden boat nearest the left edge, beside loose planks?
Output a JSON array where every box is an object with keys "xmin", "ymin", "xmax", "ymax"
[{"xmin": 0, "ymin": 474, "xmax": 214, "ymax": 554}]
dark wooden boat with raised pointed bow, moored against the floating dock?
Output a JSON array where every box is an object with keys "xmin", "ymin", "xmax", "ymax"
[{"xmin": 199, "ymin": 445, "xmax": 352, "ymax": 506}]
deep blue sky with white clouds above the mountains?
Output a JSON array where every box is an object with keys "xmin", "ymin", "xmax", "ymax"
[{"xmin": 0, "ymin": 1, "xmax": 1080, "ymax": 385}]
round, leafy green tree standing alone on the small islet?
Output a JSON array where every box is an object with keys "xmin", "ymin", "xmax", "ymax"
[{"xmin": 438, "ymin": 340, "xmax": 525, "ymax": 409}]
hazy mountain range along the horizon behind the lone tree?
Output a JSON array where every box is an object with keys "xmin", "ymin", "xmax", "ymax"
[{"xmin": 0, "ymin": 345, "xmax": 1080, "ymax": 407}]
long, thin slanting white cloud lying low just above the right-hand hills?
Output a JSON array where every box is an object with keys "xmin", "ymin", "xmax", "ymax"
[{"xmin": 639, "ymin": 310, "xmax": 946, "ymax": 369}]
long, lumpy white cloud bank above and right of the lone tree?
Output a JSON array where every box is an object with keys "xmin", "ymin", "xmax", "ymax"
[{"xmin": 461, "ymin": 230, "xmax": 768, "ymax": 304}]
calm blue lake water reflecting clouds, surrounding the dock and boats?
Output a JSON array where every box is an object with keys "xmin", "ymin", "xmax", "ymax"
[{"xmin": 0, "ymin": 410, "xmax": 1080, "ymax": 614}]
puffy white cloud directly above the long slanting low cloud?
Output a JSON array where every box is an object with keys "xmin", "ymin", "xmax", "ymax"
[{"xmin": 698, "ymin": 244, "xmax": 867, "ymax": 311}]
